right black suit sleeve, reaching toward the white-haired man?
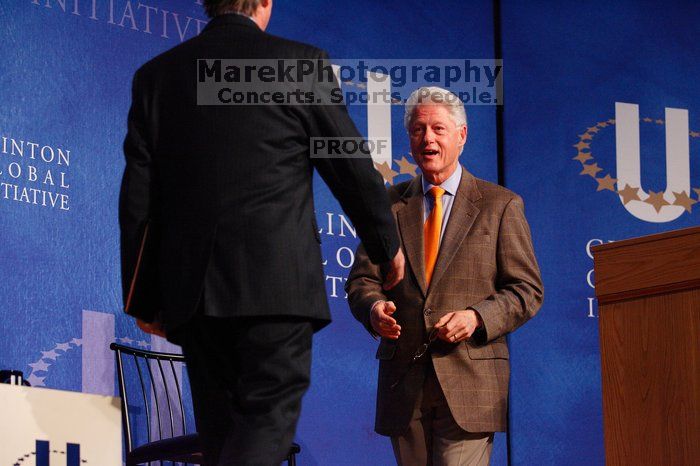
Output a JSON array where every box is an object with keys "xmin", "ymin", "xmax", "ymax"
[{"xmin": 311, "ymin": 52, "xmax": 399, "ymax": 263}]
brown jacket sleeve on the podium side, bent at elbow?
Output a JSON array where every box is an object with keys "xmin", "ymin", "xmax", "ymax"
[{"xmin": 471, "ymin": 196, "xmax": 544, "ymax": 344}]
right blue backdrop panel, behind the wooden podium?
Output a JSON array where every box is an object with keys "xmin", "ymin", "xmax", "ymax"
[{"xmin": 502, "ymin": 0, "xmax": 700, "ymax": 465}]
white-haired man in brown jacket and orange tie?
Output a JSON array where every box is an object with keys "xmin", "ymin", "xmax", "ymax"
[{"xmin": 346, "ymin": 87, "xmax": 543, "ymax": 466}]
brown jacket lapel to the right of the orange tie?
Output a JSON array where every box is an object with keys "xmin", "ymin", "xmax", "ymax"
[{"xmin": 420, "ymin": 168, "xmax": 481, "ymax": 293}]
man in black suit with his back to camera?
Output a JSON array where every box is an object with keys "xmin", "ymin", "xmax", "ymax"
[{"xmin": 120, "ymin": 0, "xmax": 404, "ymax": 466}]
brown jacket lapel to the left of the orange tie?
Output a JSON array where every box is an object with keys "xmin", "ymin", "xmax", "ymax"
[{"xmin": 397, "ymin": 175, "xmax": 427, "ymax": 297}]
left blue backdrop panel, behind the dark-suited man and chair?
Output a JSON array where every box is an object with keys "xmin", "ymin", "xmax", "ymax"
[{"xmin": 0, "ymin": 0, "xmax": 505, "ymax": 465}]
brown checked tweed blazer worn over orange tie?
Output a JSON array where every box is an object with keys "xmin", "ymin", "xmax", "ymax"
[{"xmin": 345, "ymin": 168, "xmax": 543, "ymax": 435}]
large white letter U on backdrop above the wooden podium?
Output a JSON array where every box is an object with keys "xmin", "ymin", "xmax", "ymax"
[{"xmin": 615, "ymin": 102, "xmax": 690, "ymax": 223}]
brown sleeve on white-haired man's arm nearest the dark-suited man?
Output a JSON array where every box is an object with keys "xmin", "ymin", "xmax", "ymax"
[{"xmin": 345, "ymin": 244, "xmax": 387, "ymax": 337}]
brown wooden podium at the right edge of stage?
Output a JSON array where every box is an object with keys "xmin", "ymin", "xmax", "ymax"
[{"xmin": 592, "ymin": 227, "xmax": 700, "ymax": 466}]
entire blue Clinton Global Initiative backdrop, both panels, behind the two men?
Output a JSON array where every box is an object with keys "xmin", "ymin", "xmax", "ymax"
[{"xmin": 0, "ymin": 0, "xmax": 700, "ymax": 465}]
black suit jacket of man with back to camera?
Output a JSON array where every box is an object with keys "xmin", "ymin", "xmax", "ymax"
[{"xmin": 119, "ymin": 14, "xmax": 398, "ymax": 331}]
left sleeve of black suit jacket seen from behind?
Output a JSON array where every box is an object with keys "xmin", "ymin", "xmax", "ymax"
[{"xmin": 119, "ymin": 71, "xmax": 152, "ymax": 314}]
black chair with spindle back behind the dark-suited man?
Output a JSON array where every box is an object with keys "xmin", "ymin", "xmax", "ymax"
[{"xmin": 109, "ymin": 343, "xmax": 301, "ymax": 466}]
